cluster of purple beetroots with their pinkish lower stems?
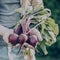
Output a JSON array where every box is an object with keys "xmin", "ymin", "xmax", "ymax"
[{"xmin": 9, "ymin": 18, "xmax": 42, "ymax": 47}]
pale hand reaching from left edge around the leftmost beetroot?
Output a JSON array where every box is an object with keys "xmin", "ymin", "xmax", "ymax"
[{"xmin": 0, "ymin": 25, "xmax": 19, "ymax": 47}]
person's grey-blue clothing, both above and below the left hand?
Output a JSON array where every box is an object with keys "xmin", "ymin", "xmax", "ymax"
[{"xmin": 0, "ymin": 0, "xmax": 23, "ymax": 60}]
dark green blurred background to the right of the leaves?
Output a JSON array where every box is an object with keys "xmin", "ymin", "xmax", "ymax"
[{"xmin": 37, "ymin": 0, "xmax": 60, "ymax": 57}]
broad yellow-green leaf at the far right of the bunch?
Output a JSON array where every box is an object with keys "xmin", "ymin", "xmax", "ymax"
[{"xmin": 46, "ymin": 18, "xmax": 59, "ymax": 36}]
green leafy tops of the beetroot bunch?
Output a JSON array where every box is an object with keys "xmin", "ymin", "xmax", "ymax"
[{"xmin": 16, "ymin": 1, "xmax": 59, "ymax": 55}]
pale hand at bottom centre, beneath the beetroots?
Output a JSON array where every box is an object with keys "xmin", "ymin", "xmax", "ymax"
[{"xmin": 21, "ymin": 43, "xmax": 36, "ymax": 60}]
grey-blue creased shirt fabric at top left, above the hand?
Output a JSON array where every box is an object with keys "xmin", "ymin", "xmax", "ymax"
[{"xmin": 0, "ymin": 0, "xmax": 20, "ymax": 27}]
